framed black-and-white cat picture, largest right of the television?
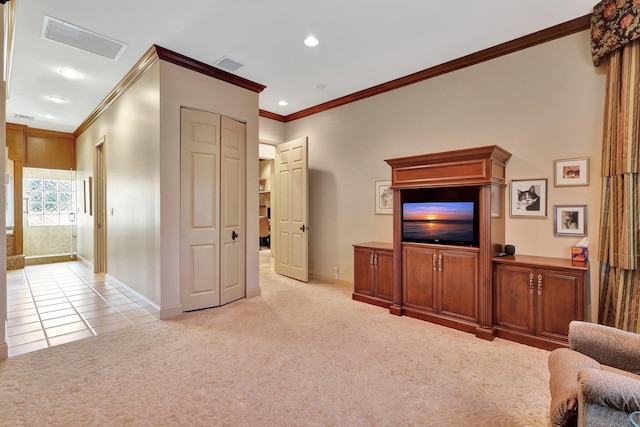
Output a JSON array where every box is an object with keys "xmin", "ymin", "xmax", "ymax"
[{"xmin": 510, "ymin": 178, "xmax": 547, "ymax": 218}]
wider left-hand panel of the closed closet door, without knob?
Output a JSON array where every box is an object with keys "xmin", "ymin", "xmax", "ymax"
[{"xmin": 180, "ymin": 108, "xmax": 220, "ymax": 311}]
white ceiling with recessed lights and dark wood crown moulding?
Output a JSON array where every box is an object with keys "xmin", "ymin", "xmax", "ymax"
[{"xmin": 7, "ymin": 0, "xmax": 595, "ymax": 132}]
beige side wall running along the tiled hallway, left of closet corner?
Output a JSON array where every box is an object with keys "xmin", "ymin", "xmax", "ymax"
[{"xmin": 77, "ymin": 64, "xmax": 161, "ymax": 306}]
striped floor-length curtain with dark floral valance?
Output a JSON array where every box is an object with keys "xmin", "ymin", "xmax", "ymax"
[{"xmin": 592, "ymin": 0, "xmax": 640, "ymax": 332}]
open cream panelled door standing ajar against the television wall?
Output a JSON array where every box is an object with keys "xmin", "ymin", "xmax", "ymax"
[{"xmin": 271, "ymin": 138, "xmax": 309, "ymax": 282}]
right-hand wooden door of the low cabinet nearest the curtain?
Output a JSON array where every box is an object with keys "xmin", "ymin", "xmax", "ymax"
[{"xmin": 536, "ymin": 268, "xmax": 584, "ymax": 341}]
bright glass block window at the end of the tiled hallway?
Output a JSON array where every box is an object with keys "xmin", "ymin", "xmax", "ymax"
[{"xmin": 27, "ymin": 178, "xmax": 75, "ymax": 227}]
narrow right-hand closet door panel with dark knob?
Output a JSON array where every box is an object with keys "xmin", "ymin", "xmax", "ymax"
[{"xmin": 220, "ymin": 116, "xmax": 246, "ymax": 304}]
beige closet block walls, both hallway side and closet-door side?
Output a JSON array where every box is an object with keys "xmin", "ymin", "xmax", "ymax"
[{"xmin": 77, "ymin": 56, "xmax": 260, "ymax": 317}]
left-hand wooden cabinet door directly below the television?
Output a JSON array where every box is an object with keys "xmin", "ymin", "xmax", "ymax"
[{"xmin": 402, "ymin": 246, "xmax": 437, "ymax": 312}]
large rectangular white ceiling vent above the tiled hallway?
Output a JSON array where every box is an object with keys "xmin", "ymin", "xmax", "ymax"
[{"xmin": 41, "ymin": 16, "xmax": 127, "ymax": 59}]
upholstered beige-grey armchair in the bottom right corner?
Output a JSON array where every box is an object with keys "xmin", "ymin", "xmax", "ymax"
[{"xmin": 549, "ymin": 321, "xmax": 640, "ymax": 426}]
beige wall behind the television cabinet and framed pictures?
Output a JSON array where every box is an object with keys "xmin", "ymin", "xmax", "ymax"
[{"xmin": 268, "ymin": 31, "xmax": 605, "ymax": 320}]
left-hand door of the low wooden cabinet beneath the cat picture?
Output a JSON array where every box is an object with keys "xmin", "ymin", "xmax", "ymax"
[{"xmin": 494, "ymin": 264, "xmax": 538, "ymax": 334}]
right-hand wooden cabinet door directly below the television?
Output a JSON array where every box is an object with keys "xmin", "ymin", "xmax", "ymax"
[{"xmin": 438, "ymin": 249, "xmax": 478, "ymax": 322}]
